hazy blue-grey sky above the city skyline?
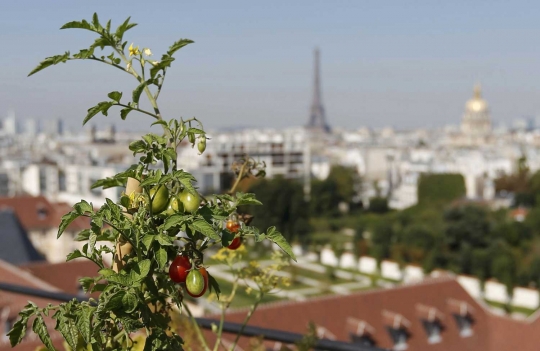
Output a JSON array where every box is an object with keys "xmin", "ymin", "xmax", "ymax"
[{"xmin": 0, "ymin": 0, "xmax": 540, "ymax": 133}]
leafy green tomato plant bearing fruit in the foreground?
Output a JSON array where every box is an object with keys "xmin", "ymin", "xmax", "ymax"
[{"xmin": 8, "ymin": 14, "xmax": 294, "ymax": 351}]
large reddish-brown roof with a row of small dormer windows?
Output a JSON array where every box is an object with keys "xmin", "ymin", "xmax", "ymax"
[{"xmin": 216, "ymin": 277, "xmax": 540, "ymax": 351}]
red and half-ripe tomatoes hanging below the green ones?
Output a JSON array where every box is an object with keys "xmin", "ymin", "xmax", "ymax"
[{"xmin": 169, "ymin": 215, "xmax": 242, "ymax": 297}]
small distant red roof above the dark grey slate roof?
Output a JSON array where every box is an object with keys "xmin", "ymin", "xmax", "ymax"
[{"xmin": 0, "ymin": 196, "xmax": 90, "ymax": 231}]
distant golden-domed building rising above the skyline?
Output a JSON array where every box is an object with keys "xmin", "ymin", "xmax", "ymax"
[{"xmin": 461, "ymin": 84, "xmax": 491, "ymax": 137}]
